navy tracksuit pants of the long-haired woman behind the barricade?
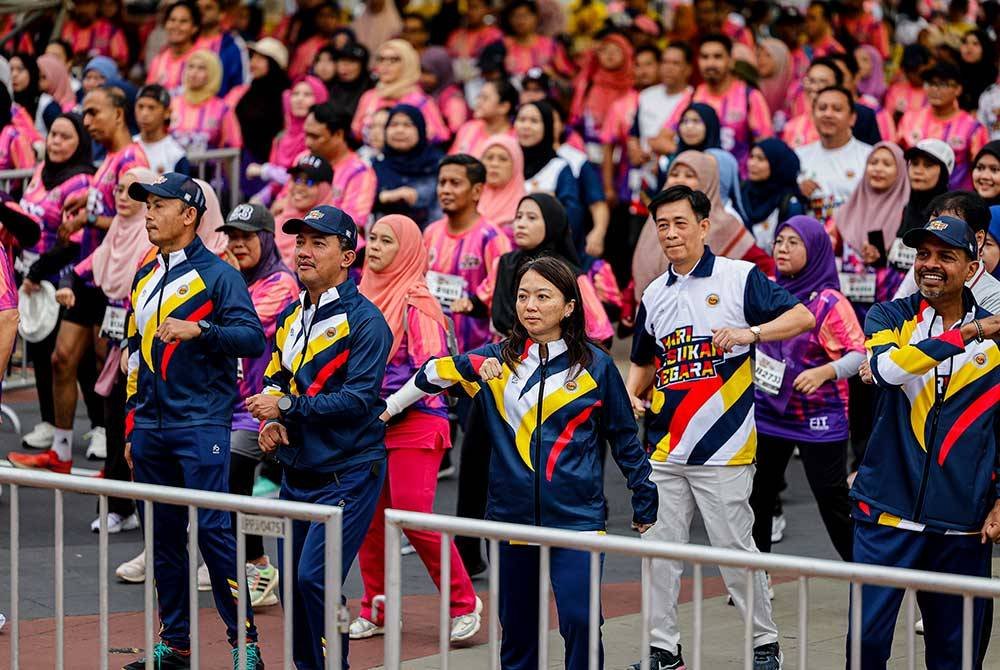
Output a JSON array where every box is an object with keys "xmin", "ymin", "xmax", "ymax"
[{"xmin": 499, "ymin": 542, "xmax": 604, "ymax": 670}]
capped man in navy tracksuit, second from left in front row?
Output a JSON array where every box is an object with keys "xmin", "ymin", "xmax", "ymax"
[{"xmin": 247, "ymin": 205, "xmax": 392, "ymax": 670}]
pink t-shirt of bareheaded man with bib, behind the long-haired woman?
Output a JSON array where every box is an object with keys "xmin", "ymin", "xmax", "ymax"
[{"xmin": 424, "ymin": 217, "xmax": 511, "ymax": 352}]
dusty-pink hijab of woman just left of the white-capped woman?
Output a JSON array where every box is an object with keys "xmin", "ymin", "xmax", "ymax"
[{"xmin": 835, "ymin": 142, "xmax": 910, "ymax": 253}]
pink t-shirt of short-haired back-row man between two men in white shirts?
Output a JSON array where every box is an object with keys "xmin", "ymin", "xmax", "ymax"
[{"xmin": 667, "ymin": 78, "xmax": 774, "ymax": 178}]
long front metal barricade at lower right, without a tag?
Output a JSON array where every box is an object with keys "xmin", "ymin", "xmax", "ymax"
[{"xmin": 384, "ymin": 509, "xmax": 1000, "ymax": 670}]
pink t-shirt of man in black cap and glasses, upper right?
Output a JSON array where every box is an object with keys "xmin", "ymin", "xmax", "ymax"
[{"xmin": 896, "ymin": 106, "xmax": 990, "ymax": 191}]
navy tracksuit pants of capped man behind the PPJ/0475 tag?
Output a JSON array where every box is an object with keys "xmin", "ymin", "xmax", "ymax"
[{"xmin": 278, "ymin": 458, "xmax": 385, "ymax": 670}]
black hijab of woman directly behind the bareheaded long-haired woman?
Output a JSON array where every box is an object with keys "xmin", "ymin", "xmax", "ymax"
[{"xmin": 491, "ymin": 193, "xmax": 583, "ymax": 335}]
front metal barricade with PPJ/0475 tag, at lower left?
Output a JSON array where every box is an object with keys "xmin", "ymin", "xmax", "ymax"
[{"xmin": 0, "ymin": 469, "xmax": 346, "ymax": 670}]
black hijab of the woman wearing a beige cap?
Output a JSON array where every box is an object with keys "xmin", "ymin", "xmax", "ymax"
[{"xmin": 236, "ymin": 54, "xmax": 292, "ymax": 163}]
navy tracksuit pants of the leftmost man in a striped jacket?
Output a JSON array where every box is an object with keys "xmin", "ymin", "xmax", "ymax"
[{"xmin": 132, "ymin": 426, "xmax": 257, "ymax": 650}]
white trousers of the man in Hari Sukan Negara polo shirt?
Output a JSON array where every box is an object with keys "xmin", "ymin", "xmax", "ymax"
[{"xmin": 642, "ymin": 462, "xmax": 778, "ymax": 654}]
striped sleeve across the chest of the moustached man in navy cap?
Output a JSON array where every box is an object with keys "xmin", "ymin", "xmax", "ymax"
[{"xmin": 865, "ymin": 304, "xmax": 965, "ymax": 386}]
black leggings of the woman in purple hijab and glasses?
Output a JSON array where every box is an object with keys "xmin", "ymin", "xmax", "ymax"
[{"xmin": 750, "ymin": 433, "xmax": 854, "ymax": 561}]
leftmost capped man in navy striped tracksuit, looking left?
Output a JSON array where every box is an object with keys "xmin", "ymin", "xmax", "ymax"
[{"xmin": 125, "ymin": 172, "xmax": 264, "ymax": 670}]
